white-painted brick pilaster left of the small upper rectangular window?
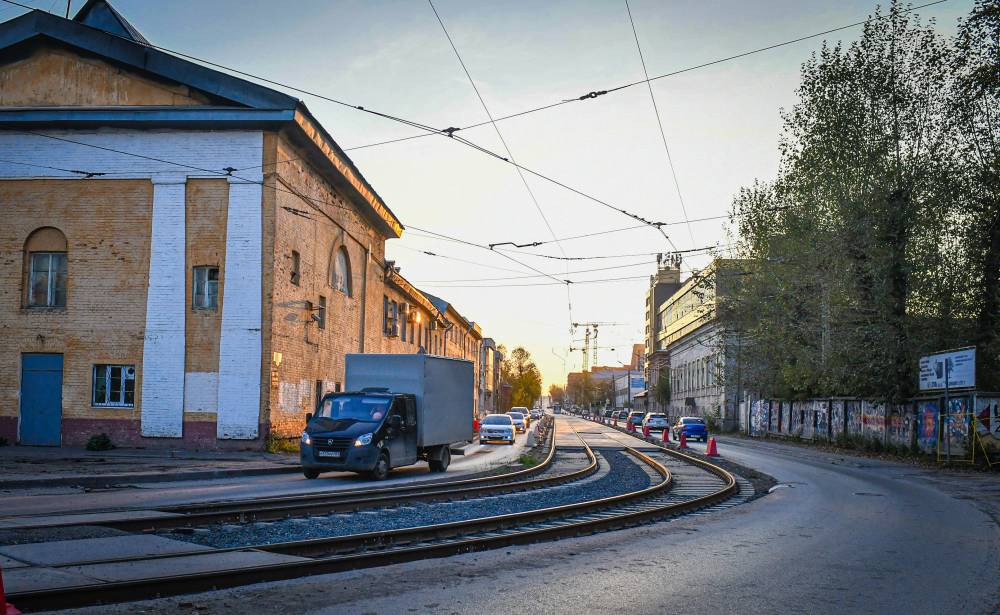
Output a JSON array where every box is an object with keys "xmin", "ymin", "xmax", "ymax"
[{"xmin": 140, "ymin": 176, "xmax": 187, "ymax": 438}]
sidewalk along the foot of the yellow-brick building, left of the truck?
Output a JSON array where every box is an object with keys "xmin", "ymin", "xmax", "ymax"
[{"xmin": 0, "ymin": 446, "xmax": 301, "ymax": 490}]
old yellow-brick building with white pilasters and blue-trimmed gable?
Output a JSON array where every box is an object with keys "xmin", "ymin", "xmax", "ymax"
[{"xmin": 0, "ymin": 0, "xmax": 500, "ymax": 447}]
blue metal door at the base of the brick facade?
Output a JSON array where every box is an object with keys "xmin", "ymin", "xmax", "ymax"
[{"xmin": 19, "ymin": 354, "xmax": 62, "ymax": 446}]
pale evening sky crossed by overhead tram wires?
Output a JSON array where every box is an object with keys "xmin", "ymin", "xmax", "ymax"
[{"xmin": 0, "ymin": 0, "xmax": 972, "ymax": 388}]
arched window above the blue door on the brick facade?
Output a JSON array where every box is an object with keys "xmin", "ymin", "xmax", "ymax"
[{"xmin": 24, "ymin": 227, "xmax": 67, "ymax": 308}]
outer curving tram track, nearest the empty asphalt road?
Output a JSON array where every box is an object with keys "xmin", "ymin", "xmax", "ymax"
[{"xmin": 9, "ymin": 445, "xmax": 745, "ymax": 611}]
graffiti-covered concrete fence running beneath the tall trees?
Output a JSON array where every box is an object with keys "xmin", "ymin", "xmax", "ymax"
[{"xmin": 739, "ymin": 393, "xmax": 1000, "ymax": 456}]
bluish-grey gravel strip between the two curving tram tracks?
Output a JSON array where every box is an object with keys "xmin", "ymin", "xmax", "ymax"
[{"xmin": 164, "ymin": 450, "xmax": 655, "ymax": 548}]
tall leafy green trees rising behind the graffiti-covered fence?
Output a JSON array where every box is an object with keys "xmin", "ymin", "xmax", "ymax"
[{"xmin": 720, "ymin": 0, "xmax": 1000, "ymax": 400}]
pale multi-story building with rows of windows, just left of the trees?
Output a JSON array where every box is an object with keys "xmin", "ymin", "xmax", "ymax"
[{"xmin": 656, "ymin": 259, "xmax": 741, "ymax": 428}]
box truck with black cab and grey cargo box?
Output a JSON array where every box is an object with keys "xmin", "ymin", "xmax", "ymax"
[{"xmin": 299, "ymin": 354, "xmax": 474, "ymax": 480}]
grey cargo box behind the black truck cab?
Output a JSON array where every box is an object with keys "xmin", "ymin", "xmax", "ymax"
[{"xmin": 345, "ymin": 354, "xmax": 474, "ymax": 448}]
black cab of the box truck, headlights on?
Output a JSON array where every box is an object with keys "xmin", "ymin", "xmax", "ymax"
[{"xmin": 299, "ymin": 389, "xmax": 434, "ymax": 479}]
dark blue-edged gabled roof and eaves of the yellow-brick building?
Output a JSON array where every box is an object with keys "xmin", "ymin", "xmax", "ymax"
[{"xmin": 0, "ymin": 0, "xmax": 403, "ymax": 237}]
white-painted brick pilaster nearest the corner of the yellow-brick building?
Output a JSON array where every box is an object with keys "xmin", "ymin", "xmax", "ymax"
[{"xmin": 216, "ymin": 179, "xmax": 263, "ymax": 440}]
